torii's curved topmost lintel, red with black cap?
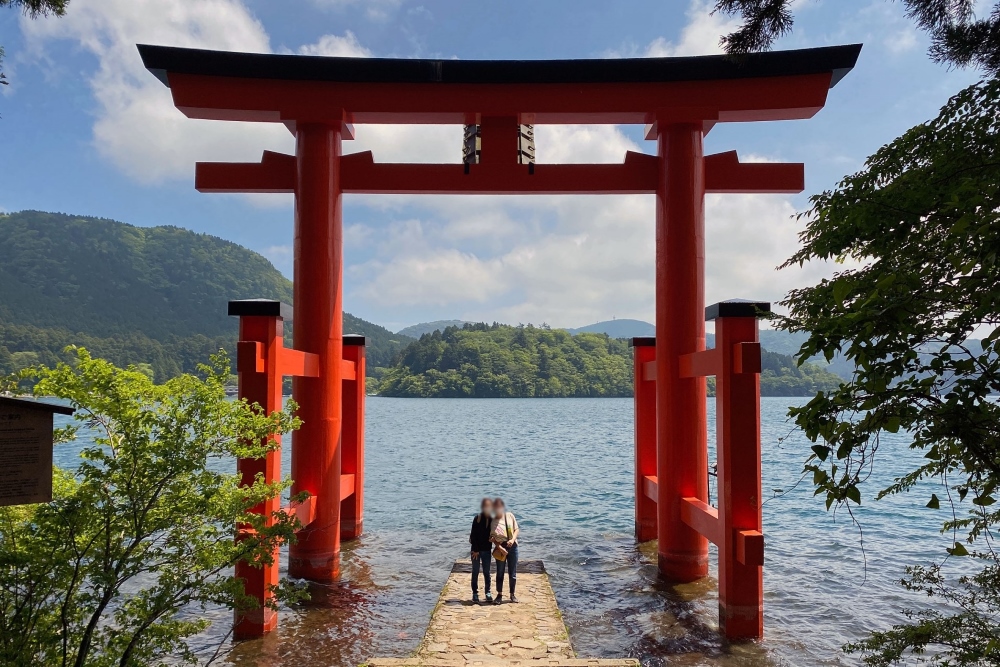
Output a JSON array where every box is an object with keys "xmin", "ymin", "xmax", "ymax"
[{"xmin": 139, "ymin": 45, "xmax": 861, "ymax": 124}]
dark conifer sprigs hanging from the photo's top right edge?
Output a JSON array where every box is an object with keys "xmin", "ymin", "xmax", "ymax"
[{"xmin": 715, "ymin": 0, "xmax": 1000, "ymax": 74}]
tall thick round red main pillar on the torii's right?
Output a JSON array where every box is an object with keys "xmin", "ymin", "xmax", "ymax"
[{"xmin": 656, "ymin": 124, "xmax": 708, "ymax": 581}]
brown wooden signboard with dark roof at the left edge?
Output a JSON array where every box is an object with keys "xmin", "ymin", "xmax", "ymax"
[{"xmin": 0, "ymin": 396, "xmax": 73, "ymax": 505}]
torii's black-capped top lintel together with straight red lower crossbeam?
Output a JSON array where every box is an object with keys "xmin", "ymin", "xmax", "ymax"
[{"xmin": 139, "ymin": 45, "xmax": 861, "ymax": 194}]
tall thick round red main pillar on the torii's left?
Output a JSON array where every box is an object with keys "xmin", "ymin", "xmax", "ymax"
[{"xmin": 288, "ymin": 123, "xmax": 343, "ymax": 581}]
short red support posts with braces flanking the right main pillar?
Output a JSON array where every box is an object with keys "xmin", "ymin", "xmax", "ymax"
[{"xmin": 632, "ymin": 301, "xmax": 770, "ymax": 641}]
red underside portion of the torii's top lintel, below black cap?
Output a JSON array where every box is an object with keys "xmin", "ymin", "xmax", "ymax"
[{"xmin": 167, "ymin": 72, "xmax": 832, "ymax": 129}]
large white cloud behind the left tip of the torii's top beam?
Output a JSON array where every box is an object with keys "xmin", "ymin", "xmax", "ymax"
[{"xmin": 21, "ymin": 0, "xmax": 292, "ymax": 183}]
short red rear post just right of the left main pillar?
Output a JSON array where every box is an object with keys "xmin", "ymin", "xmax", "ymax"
[{"xmin": 340, "ymin": 336, "xmax": 366, "ymax": 540}]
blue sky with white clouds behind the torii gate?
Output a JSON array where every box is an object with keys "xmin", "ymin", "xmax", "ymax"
[{"xmin": 0, "ymin": 0, "xmax": 977, "ymax": 330}]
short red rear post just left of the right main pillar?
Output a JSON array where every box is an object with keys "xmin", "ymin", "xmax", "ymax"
[{"xmin": 632, "ymin": 338, "xmax": 656, "ymax": 542}]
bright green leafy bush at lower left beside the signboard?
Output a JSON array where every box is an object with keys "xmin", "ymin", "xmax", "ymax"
[{"xmin": 0, "ymin": 349, "xmax": 298, "ymax": 667}]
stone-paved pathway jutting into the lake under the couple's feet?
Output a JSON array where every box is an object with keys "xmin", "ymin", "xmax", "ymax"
[{"xmin": 367, "ymin": 561, "xmax": 639, "ymax": 667}]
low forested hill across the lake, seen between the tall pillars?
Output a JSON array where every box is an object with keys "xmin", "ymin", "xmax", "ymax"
[{"xmin": 379, "ymin": 323, "xmax": 841, "ymax": 398}]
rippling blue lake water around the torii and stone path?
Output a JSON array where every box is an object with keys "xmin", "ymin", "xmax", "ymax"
[{"xmin": 57, "ymin": 397, "xmax": 948, "ymax": 667}]
